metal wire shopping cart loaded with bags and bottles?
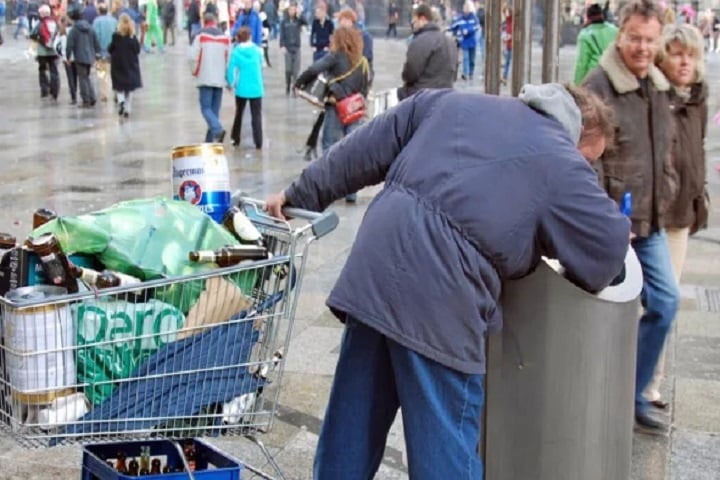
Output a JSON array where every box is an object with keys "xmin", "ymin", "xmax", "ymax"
[{"xmin": 0, "ymin": 192, "xmax": 338, "ymax": 478}]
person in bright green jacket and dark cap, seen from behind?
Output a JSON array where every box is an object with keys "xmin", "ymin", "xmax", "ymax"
[{"xmin": 575, "ymin": 3, "xmax": 617, "ymax": 85}]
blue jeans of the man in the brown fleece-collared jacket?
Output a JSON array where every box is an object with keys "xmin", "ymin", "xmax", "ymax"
[{"xmin": 632, "ymin": 231, "xmax": 680, "ymax": 414}]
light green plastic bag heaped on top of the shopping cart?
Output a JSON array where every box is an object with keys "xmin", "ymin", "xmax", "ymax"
[{"xmin": 32, "ymin": 197, "xmax": 255, "ymax": 314}]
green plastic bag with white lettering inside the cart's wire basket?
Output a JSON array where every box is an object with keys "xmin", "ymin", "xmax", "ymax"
[{"xmin": 71, "ymin": 299, "xmax": 185, "ymax": 405}]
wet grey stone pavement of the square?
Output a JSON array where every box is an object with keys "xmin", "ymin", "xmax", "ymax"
[{"xmin": 0, "ymin": 26, "xmax": 720, "ymax": 480}]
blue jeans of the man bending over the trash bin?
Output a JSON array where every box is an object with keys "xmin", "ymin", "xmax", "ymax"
[{"xmin": 314, "ymin": 317, "xmax": 484, "ymax": 480}]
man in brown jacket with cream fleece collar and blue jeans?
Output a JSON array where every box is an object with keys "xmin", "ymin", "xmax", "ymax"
[{"xmin": 585, "ymin": 0, "xmax": 679, "ymax": 432}]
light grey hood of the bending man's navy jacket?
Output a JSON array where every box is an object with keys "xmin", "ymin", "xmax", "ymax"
[{"xmin": 518, "ymin": 83, "xmax": 582, "ymax": 145}]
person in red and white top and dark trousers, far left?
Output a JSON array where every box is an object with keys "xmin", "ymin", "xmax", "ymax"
[{"xmin": 30, "ymin": 5, "xmax": 60, "ymax": 100}]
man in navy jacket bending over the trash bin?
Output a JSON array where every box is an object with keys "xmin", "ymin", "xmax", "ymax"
[{"xmin": 267, "ymin": 85, "xmax": 630, "ymax": 480}]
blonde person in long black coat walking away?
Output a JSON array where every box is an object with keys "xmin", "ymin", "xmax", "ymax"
[{"xmin": 108, "ymin": 14, "xmax": 142, "ymax": 118}]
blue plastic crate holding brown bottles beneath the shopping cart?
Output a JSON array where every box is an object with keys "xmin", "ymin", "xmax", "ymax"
[{"xmin": 82, "ymin": 439, "xmax": 243, "ymax": 480}]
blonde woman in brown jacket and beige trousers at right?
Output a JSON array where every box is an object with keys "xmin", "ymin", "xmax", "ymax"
[{"xmin": 645, "ymin": 24, "xmax": 708, "ymax": 409}]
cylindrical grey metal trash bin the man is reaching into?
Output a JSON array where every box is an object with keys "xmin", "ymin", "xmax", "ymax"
[{"xmin": 483, "ymin": 249, "xmax": 642, "ymax": 480}]
